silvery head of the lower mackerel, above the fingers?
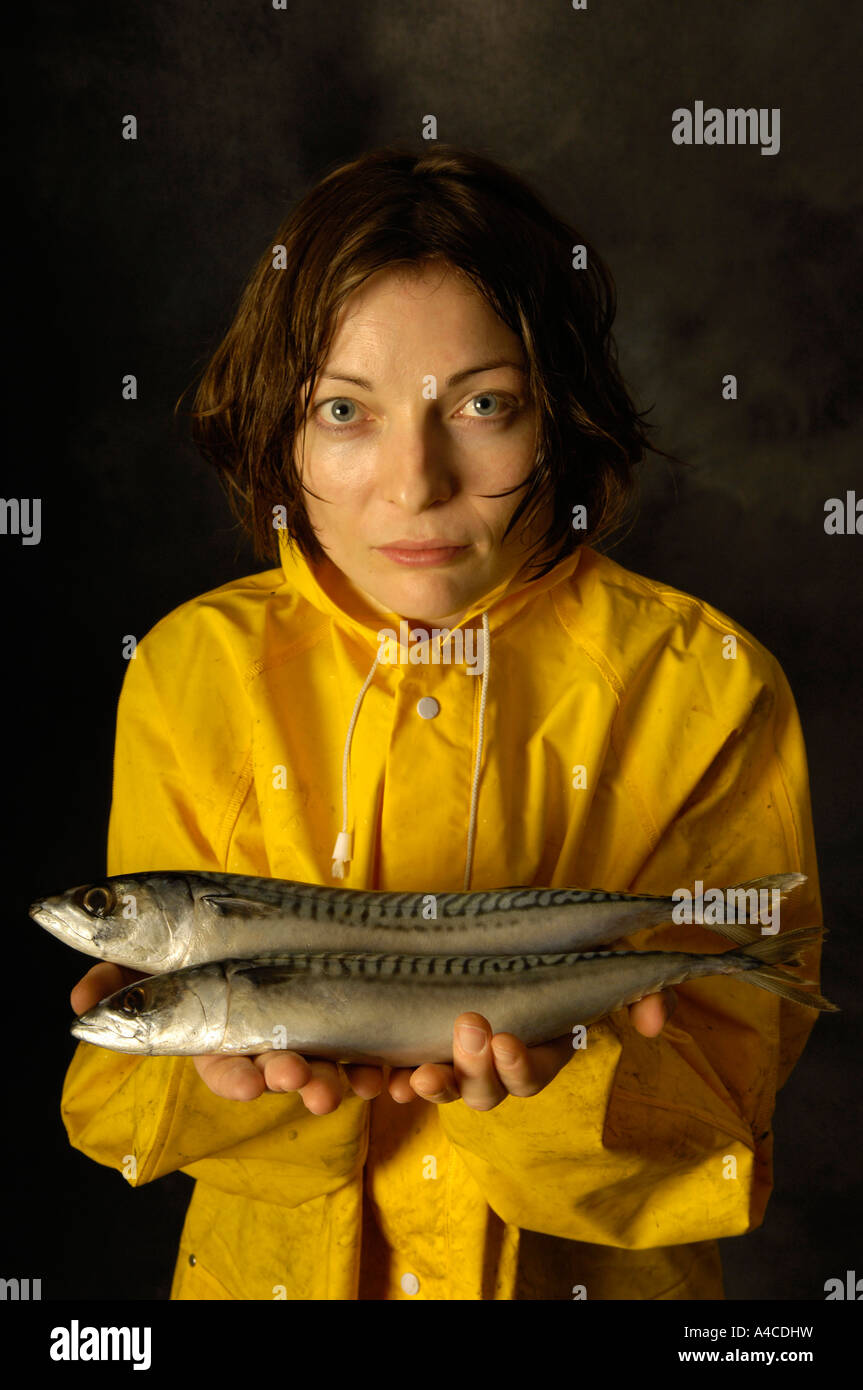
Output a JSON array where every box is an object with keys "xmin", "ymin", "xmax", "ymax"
[{"xmin": 69, "ymin": 963, "xmax": 228, "ymax": 1056}]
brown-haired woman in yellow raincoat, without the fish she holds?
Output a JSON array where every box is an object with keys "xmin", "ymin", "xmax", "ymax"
[{"xmin": 63, "ymin": 147, "xmax": 820, "ymax": 1300}]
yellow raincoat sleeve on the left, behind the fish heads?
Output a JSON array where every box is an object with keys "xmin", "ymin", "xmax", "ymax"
[{"xmin": 61, "ymin": 620, "xmax": 363, "ymax": 1207}]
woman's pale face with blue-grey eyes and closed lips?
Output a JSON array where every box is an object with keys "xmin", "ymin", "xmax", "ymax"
[{"xmin": 297, "ymin": 264, "xmax": 549, "ymax": 627}]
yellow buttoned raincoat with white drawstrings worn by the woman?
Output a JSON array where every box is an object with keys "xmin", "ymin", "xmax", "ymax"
[{"xmin": 63, "ymin": 535, "xmax": 821, "ymax": 1300}]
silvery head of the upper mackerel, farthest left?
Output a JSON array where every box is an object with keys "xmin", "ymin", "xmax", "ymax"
[{"xmin": 29, "ymin": 874, "xmax": 192, "ymax": 973}]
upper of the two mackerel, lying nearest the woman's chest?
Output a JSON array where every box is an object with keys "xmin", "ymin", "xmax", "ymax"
[{"xmin": 29, "ymin": 872, "xmax": 806, "ymax": 974}]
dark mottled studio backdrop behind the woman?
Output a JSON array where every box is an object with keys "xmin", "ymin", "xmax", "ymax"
[{"xmin": 0, "ymin": 0, "xmax": 863, "ymax": 1300}]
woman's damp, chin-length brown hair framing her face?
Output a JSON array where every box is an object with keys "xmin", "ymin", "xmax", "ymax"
[{"xmin": 183, "ymin": 145, "xmax": 674, "ymax": 574}]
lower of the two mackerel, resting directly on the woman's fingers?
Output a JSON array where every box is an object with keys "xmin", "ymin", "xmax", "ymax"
[{"xmin": 71, "ymin": 927, "xmax": 835, "ymax": 1066}]
